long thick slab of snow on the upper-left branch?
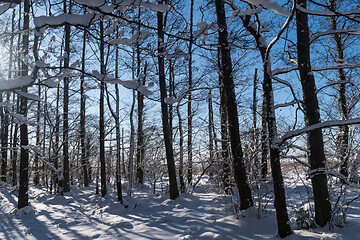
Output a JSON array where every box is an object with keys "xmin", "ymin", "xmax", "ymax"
[{"xmin": 34, "ymin": 13, "xmax": 95, "ymax": 28}]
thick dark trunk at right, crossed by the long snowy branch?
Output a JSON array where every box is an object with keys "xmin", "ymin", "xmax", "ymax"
[{"xmin": 296, "ymin": 0, "xmax": 331, "ymax": 226}]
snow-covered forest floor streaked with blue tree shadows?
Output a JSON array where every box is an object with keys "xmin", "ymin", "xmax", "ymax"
[{"xmin": 0, "ymin": 173, "xmax": 360, "ymax": 240}]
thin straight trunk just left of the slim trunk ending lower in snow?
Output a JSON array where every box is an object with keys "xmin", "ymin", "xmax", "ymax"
[{"xmin": 99, "ymin": 20, "xmax": 107, "ymax": 197}]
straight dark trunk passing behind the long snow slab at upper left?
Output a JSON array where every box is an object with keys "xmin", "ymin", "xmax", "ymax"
[{"xmin": 61, "ymin": 0, "xmax": 71, "ymax": 194}]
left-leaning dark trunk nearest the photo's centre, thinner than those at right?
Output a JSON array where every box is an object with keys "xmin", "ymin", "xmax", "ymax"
[{"xmin": 157, "ymin": 1, "xmax": 179, "ymax": 200}]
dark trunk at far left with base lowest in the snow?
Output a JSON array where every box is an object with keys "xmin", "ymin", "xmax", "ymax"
[{"xmin": 18, "ymin": 0, "xmax": 30, "ymax": 209}]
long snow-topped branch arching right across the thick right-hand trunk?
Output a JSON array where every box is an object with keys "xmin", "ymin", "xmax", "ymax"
[{"xmin": 274, "ymin": 118, "xmax": 360, "ymax": 146}]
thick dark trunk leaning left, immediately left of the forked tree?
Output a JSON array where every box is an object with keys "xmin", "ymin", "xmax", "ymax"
[{"xmin": 215, "ymin": 0, "xmax": 253, "ymax": 209}]
